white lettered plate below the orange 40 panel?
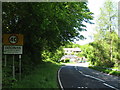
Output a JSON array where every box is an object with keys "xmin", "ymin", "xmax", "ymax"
[{"xmin": 4, "ymin": 45, "xmax": 23, "ymax": 54}]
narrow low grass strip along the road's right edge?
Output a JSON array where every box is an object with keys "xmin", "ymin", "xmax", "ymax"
[{"xmin": 89, "ymin": 66, "xmax": 120, "ymax": 76}]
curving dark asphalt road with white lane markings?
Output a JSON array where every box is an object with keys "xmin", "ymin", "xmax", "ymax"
[{"xmin": 58, "ymin": 64, "xmax": 120, "ymax": 90}]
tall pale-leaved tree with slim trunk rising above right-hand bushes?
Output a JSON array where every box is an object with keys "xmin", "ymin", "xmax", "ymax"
[{"xmin": 96, "ymin": 0, "xmax": 117, "ymax": 64}]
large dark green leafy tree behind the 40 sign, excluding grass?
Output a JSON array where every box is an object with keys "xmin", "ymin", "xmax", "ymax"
[{"xmin": 2, "ymin": 2, "xmax": 93, "ymax": 87}]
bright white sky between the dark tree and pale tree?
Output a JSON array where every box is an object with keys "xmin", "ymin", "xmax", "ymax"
[{"xmin": 75, "ymin": 0, "xmax": 120, "ymax": 45}]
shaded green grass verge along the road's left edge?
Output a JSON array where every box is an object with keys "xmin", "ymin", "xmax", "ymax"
[{"xmin": 12, "ymin": 62, "xmax": 60, "ymax": 88}]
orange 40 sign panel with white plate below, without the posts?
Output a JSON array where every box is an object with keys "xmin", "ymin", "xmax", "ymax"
[{"xmin": 3, "ymin": 34, "xmax": 23, "ymax": 54}]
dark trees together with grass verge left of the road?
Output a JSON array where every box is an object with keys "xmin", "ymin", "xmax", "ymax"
[{"xmin": 2, "ymin": 2, "xmax": 93, "ymax": 88}]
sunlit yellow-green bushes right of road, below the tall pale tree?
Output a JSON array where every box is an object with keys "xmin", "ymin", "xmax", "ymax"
[{"xmin": 81, "ymin": 32, "xmax": 120, "ymax": 67}]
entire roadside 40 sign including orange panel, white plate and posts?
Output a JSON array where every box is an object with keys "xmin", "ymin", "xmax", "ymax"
[{"xmin": 3, "ymin": 34, "xmax": 23, "ymax": 80}]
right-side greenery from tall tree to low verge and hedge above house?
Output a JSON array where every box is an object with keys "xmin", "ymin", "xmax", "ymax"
[{"xmin": 60, "ymin": 0, "xmax": 120, "ymax": 75}]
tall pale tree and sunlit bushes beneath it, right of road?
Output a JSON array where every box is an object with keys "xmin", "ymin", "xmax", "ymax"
[{"xmin": 84, "ymin": 0, "xmax": 120, "ymax": 67}]
